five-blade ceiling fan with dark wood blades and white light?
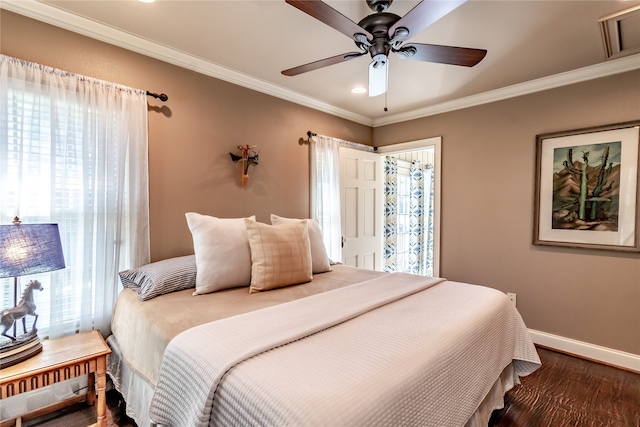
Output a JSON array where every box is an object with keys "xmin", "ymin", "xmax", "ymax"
[{"xmin": 282, "ymin": 0, "xmax": 487, "ymax": 96}]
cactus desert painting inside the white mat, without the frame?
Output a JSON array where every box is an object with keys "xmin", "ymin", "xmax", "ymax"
[{"xmin": 552, "ymin": 141, "xmax": 622, "ymax": 231}]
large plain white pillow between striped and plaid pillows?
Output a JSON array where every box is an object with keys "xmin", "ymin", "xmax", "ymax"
[{"xmin": 185, "ymin": 212, "xmax": 255, "ymax": 295}]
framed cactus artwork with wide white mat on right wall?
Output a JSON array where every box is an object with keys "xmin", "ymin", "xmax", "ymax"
[{"xmin": 533, "ymin": 120, "xmax": 640, "ymax": 252}]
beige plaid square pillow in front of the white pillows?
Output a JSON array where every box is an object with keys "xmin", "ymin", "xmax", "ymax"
[{"xmin": 244, "ymin": 219, "xmax": 313, "ymax": 293}]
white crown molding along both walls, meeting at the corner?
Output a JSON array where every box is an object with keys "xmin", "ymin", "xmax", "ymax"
[{"xmin": 0, "ymin": 0, "xmax": 640, "ymax": 128}]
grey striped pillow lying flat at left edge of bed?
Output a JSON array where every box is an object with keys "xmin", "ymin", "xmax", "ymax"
[{"xmin": 119, "ymin": 255, "xmax": 196, "ymax": 301}]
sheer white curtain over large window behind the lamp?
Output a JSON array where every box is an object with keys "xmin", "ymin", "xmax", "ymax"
[{"xmin": 0, "ymin": 55, "xmax": 149, "ymax": 338}]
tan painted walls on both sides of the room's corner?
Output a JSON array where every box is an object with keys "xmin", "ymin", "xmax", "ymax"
[{"xmin": 0, "ymin": 10, "xmax": 640, "ymax": 354}]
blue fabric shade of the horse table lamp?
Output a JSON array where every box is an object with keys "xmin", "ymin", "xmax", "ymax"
[{"xmin": 0, "ymin": 224, "xmax": 65, "ymax": 278}]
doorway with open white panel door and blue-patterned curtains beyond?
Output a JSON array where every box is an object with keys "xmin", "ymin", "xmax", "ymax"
[{"xmin": 340, "ymin": 137, "xmax": 441, "ymax": 276}]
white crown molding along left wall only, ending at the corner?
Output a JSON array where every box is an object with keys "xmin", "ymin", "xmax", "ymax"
[{"xmin": 0, "ymin": 0, "xmax": 373, "ymax": 126}]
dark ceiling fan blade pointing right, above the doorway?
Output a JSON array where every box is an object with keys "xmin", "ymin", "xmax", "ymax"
[{"xmin": 394, "ymin": 43, "xmax": 487, "ymax": 67}]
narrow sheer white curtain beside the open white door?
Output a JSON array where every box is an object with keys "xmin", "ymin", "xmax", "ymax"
[{"xmin": 309, "ymin": 135, "xmax": 342, "ymax": 262}]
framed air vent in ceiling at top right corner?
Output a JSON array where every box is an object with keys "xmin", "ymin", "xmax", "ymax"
[{"xmin": 598, "ymin": 5, "xmax": 640, "ymax": 59}]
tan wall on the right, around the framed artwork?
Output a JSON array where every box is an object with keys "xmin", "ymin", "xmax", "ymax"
[{"xmin": 374, "ymin": 71, "xmax": 640, "ymax": 354}]
